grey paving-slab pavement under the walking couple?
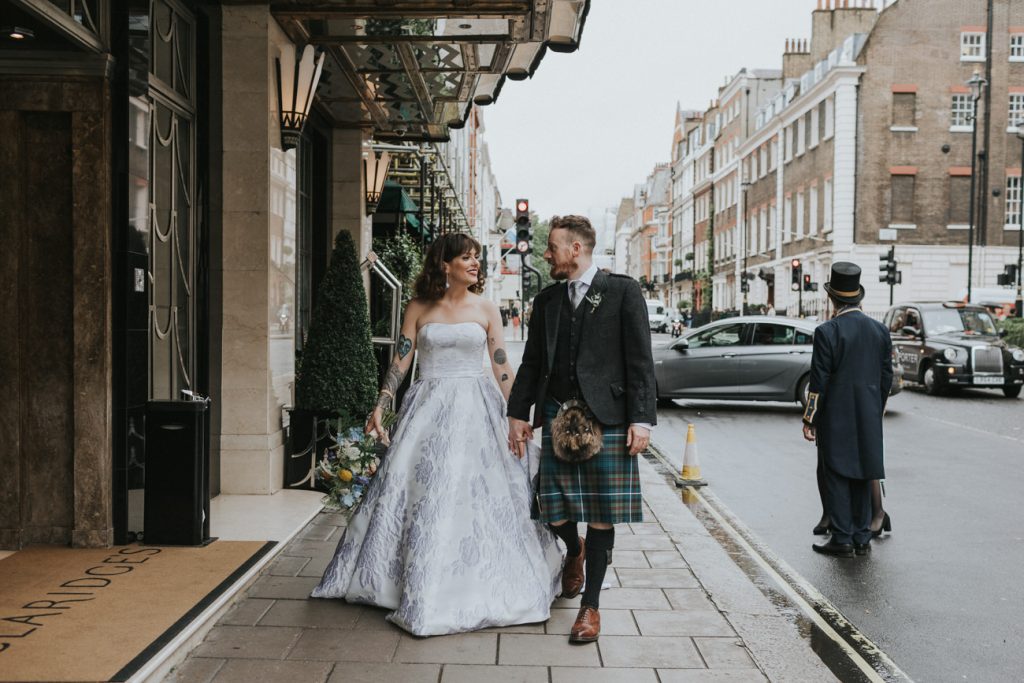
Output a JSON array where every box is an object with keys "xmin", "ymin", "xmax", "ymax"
[{"xmin": 165, "ymin": 343, "xmax": 836, "ymax": 683}]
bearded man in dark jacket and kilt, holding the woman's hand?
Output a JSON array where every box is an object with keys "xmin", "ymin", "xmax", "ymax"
[{"xmin": 508, "ymin": 216, "xmax": 656, "ymax": 643}]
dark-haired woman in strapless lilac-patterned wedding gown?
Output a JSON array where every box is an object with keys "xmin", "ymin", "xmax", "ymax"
[{"xmin": 312, "ymin": 233, "xmax": 561, "ymax": 636}]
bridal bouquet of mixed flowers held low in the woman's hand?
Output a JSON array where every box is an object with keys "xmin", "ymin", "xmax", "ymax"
[{"xmin": 316, "ymin": 414, "xmax": 394, "ymax": 512}]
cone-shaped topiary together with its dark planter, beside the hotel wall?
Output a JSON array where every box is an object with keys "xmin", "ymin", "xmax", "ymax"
[{"xmin": 285, "ymin": 230, "xmax": 377, "ymax": 488}]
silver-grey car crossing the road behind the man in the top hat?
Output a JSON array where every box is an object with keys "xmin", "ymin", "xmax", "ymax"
[{"xmin": 654, "ymin": 315, "xmax": 902, "ymax": 405}]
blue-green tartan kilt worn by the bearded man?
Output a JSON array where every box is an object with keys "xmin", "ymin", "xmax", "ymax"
[{"xmin": 534, "ymin": 399, "xmax": 643, "ymax": 524}]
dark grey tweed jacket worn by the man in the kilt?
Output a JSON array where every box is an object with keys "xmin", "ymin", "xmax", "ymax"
[{"xmin": 508, "ymin": 270, "xmax": 657, "ymax": 427}]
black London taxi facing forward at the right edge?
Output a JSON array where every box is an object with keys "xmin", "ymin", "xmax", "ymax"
[{"xmin": 883, "ymin": 301, "xmax": 1024, "ymax": 398}]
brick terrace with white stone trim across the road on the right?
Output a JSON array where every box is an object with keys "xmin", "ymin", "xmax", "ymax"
[{"xmin": 672, "ymin": 0, "xmax": 1024, "ymax": 314}]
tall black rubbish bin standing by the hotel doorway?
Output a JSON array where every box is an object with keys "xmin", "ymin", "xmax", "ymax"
[{"xmin": 143, "ymin": 398, "xmax": 211, "ymax": 546}]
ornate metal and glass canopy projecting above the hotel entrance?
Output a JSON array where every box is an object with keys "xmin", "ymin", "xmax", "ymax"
[{"xmin": 271, "ymin": 0, "xmax": 590, "ymax": 142}]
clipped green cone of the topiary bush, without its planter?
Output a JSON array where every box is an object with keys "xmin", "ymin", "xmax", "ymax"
[{"xmin": 295, "ymin": 230, "xmax": 377, "ymax": 420}]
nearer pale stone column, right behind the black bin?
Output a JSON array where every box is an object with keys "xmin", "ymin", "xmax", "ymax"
[{"xmin": 212, "ymin": 5, "xmax": 284, "ymax": 494}]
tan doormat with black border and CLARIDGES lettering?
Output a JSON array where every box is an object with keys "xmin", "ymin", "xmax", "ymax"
[{"xmin": 0, "ymin": 541, "xmax": 275, "ymax": 681}]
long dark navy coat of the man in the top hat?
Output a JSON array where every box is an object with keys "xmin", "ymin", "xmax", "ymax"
[{"xmin": 804, "ymin": 310, "xmax": 893, "ymax": 479}]
